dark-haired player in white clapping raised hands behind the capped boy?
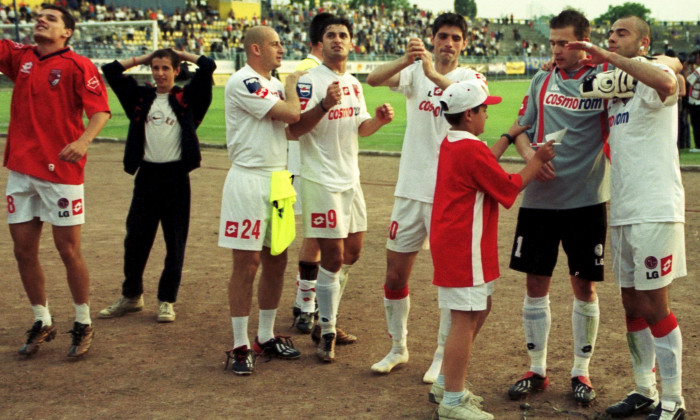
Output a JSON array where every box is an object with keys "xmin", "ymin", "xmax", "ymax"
[{"xmin": 367, "ymin": 13, "xmax": 504, "ymax": 383}]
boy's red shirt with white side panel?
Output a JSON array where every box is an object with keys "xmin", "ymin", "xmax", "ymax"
[{"xmin": 430, "ymin": 130, "xmax": 522, "ymax": 287}]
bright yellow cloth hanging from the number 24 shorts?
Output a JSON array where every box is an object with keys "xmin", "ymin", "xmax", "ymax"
[{"xmin": 270, "ymin": 170, "xmax": 297, "ymax": 255}]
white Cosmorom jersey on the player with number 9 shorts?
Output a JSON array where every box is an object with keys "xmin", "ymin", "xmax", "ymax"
[{"xmin": 297, "ymin": 65, "xmax": 371, "ymax": 191}]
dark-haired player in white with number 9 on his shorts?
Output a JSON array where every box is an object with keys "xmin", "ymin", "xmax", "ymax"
[{"xmin": 289, "ymin": 17, "xmax": 394, "ymax": 362}]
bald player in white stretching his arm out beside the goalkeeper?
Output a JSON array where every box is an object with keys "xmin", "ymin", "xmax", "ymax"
[{"xmin": 570, "ymin": 16, "xmax": 686, "ymax": 420}]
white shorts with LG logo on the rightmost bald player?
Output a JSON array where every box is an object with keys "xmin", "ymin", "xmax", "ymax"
[{"xmin": 610, "ymin": 223, "xmax": 687, "ymax": 290}]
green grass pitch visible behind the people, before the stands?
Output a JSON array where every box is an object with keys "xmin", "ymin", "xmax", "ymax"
[{"xmin": 0, "ymin": 81, "xmax": 700, "ymax": 165}]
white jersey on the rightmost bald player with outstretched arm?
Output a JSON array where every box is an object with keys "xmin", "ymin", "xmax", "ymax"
[{"xmin": 608, "ymin": 64, "xmax": 685, "ymax": 226}]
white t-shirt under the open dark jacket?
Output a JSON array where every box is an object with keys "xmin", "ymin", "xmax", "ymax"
[{"xmin": 143, "ymin": 93, "xmax": 182, "ymax": 163}]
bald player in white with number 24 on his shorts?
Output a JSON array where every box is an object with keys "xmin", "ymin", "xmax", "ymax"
[{"xmin": 219, "ymin": 26, "xmax": 300, "ymax": 375}]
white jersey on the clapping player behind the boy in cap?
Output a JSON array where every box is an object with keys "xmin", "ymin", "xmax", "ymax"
[{"xmin": 392, "ymin": 62, "xmax": 486, "ymax": 203}]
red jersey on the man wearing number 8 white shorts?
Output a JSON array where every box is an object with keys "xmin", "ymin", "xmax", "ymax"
[{"xmin": 0, "ymin": 40, "xmax": 109, "ymax": 185}]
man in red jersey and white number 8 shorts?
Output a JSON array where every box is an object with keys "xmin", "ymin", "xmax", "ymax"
[{"xmin": 0, "ymin": 6, "xmax": 110, "ymax": 357}]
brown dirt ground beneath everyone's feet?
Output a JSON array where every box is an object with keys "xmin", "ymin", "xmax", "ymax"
[{"xmin": 0, "ymin": 140, "xmax": 700, "ymax": 419}]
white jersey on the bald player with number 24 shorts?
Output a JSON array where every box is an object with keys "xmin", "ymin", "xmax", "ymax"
[{"xmin": 224, "ymin": 64, "xmax": 287, "ymax": 171}]
